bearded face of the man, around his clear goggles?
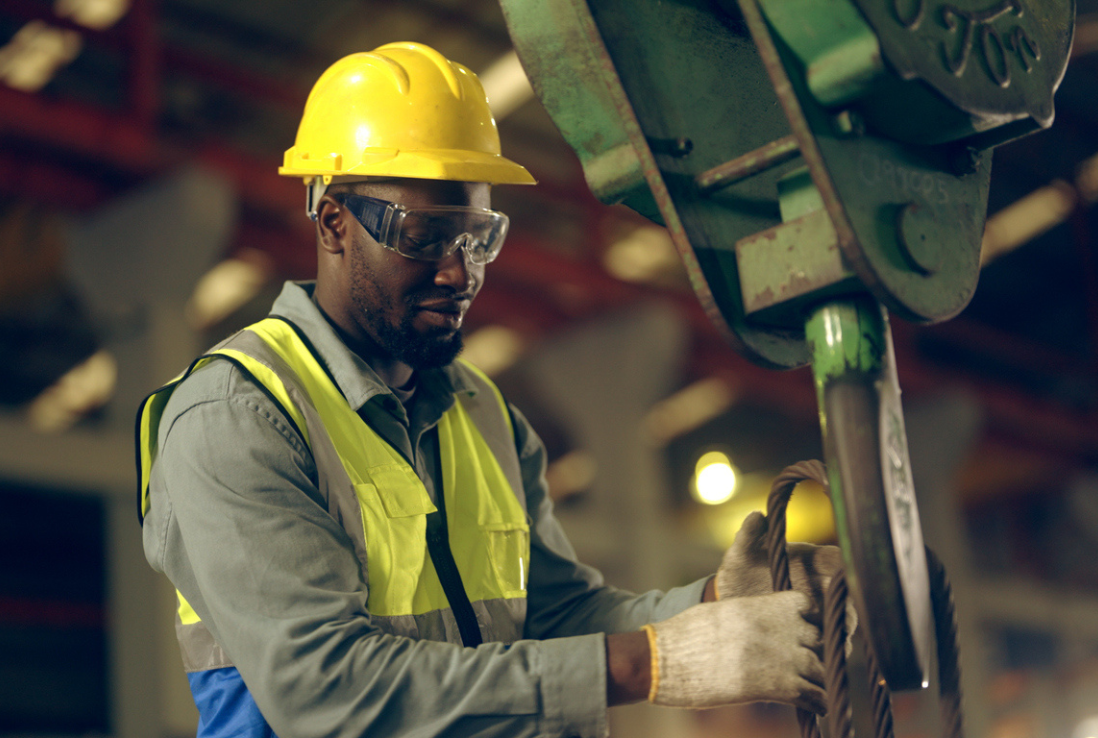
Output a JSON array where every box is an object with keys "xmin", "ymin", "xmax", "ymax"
[{"xmin": 345, "ymin": 179, "xmax": 491, "ymax": 369}]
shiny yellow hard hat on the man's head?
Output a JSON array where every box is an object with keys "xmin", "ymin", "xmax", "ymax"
[{"xmin": 279, "ymin": 43, "xmax": 536, "ymax": 193}]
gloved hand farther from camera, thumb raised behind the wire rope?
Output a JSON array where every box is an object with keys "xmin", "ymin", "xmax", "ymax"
[{"xmin": 716, "ymin": 512, "xmax": 838, "ymax": 606}]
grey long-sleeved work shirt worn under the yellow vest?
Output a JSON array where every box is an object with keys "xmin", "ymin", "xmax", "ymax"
[{"xmin": 143, "ymin": 282, "xmax": 705, "ymax": 738}]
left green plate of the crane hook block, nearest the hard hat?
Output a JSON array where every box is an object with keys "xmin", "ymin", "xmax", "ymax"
[{"xmin": 501, "ymin": 0, "xmax": 808, "ymax": 368}]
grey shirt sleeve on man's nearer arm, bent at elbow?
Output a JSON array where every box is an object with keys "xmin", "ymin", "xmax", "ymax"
[{"xmin": 144, "ymin": 362, "xmax": 608, "ymax": 738}]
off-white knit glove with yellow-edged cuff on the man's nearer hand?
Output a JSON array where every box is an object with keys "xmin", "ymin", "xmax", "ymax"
[{"xmin": 645, "ymin": 592, "xmax": 826, "ymax": 713}]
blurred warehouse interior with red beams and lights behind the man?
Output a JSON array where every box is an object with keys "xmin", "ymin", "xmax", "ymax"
[{"xmin": 0, "ymin": 0, "xmax": 1098, "ymax": 738}]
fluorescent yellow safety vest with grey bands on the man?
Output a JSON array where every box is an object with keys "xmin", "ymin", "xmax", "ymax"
[{"xmin": 137, "ymin": 318, "xmax": 530, "ymax": 671}]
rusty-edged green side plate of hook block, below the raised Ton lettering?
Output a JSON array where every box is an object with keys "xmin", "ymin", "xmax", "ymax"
[{"xmin": 739, "ymin": 0, "xmax": 990, "ymax": 322}]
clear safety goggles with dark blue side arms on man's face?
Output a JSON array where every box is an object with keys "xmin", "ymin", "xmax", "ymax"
[{"xmin": 333, "ymin": 192, "xmax": 508, "ymax": 265}]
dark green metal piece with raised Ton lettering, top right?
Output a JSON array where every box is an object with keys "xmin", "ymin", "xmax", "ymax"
[{"xmin": 853, "ymin": 0, "xmax": 1075, "ymax": 147}]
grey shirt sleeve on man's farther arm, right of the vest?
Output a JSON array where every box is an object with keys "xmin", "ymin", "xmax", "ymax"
[{"xmin": 511, "ymin": 405, "xmax": 706, "ymax": 638}]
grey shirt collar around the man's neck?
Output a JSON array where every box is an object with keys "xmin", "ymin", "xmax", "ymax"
[{"xmin": 270, "ymin": 281, "xmax": 477, "ymax": 412}]
